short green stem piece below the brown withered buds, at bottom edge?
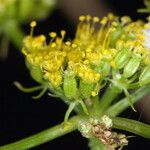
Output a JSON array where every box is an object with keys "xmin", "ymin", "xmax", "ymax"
[{"xmin": 89, "ymin": 137, "xmax": 107, "ymax": 150}]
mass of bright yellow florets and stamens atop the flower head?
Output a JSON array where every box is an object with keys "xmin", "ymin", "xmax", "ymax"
[{"xmin": 22, "ymin": 14, "xmax": 150, "ymax": 90}]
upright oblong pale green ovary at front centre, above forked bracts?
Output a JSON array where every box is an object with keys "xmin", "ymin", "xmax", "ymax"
[{"xmin": 63, "ymin": 71, "xmax": 77, "ymax": 99}]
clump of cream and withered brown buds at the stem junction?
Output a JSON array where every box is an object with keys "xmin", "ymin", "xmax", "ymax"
[{"xmin": 79, "ymin": 115, "xmax": 128, "ymax": 150}]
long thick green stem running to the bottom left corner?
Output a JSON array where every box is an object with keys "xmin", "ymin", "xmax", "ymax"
[{"xmin": 0, "ymin": 116, "xmax": 81, "ymax": 150}]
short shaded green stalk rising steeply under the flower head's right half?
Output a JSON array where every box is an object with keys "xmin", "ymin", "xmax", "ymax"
[{"xmin": 101, "ymin": 85, "xmax": 120, "ymax": 112}]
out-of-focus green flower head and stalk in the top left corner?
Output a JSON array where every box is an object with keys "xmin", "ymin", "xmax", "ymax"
[{"xmin": 0, "ymin": 0, "xmax": 56, "ymax": 59}]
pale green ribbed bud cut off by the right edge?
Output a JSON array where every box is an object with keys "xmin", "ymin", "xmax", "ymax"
[{"xmin": 139, "ymin": 64, "xmax": 150, "ymax": 86}]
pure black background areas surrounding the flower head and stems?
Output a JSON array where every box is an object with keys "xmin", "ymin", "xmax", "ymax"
[{"xmin": 0, "ymin": 0, "xmax": 150, "ymax": 150}]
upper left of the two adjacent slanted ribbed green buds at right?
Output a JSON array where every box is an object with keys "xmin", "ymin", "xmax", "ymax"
[{"xmin": 114, "ymin": 49, "xmax": 130, "ymax": 69}]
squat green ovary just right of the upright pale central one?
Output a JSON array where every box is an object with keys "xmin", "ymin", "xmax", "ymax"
[{"xmin": 79, "ymin": 79, "xmax": 96, "ymax": 99}]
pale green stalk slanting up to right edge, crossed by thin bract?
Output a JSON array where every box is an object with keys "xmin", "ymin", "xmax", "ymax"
[{"xmin": 106, "ymin": 85, "xmax": 150, "ymax": 116}]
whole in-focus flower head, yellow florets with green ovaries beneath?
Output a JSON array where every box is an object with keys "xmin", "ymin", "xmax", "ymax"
[{"xmin": 22, "ymin": 14, "xmax": 150, "ymax": 109}]
